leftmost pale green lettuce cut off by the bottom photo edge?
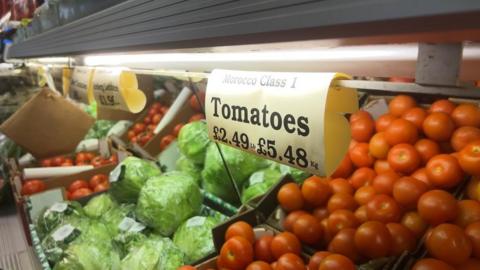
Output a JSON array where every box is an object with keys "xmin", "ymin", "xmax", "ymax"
[{"xmin": 53, "ymin": 242, "xmax": 120, "ymax": 270}]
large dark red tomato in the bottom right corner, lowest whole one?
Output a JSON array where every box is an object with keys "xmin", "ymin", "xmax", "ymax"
[{"xmin": 425, "ymin": 224, "xmax": 472, "ymax": 265}]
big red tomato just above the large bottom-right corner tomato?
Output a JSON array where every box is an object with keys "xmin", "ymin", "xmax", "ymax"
[{"xmin": 417, "ymin": 190, "xmax": 458, "ymax": 225}]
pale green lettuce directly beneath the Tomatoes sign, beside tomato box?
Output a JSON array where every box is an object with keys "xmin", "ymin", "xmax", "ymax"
[{"xmin": 242, "ymin": 168, "xmax": 282, "ymax": 203}]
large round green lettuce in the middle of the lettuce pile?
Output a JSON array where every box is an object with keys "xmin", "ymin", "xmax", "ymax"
[{"xmin": 136, "ymin": 171, "xmax": 202, "ymax": 236}]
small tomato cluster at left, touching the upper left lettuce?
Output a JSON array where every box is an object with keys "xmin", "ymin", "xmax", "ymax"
[{"xmin": 66, "ymin": 174, "xmax": 110, "ymax": 200}]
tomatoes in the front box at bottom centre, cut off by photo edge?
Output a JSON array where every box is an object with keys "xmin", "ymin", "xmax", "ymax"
[{"xmin": 180, "ymin": 221, "xmax": 356, "ymax": 270}]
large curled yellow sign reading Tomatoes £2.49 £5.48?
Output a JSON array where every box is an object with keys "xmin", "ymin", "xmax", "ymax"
[{"xmin": 205, "ymin": 70, "xmax": 358, "ymax": 175}]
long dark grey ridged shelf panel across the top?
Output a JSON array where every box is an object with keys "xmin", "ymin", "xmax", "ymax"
[{"xmin": 8, "ymin": 0, "xmax": 480, "ymax": 58}]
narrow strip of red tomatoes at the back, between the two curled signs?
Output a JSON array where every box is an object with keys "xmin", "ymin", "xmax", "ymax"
[{"xmin": 127, "ymin": 102, "xmax": 169, "ymax": 146}]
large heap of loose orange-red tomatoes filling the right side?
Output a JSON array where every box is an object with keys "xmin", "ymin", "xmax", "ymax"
[{"xmin": 277, "ymin": 95, "xmax": 480, "ymax": 269}]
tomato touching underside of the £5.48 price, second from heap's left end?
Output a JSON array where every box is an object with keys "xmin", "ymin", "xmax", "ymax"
[{"xmin": 301, "ymin": 176, "xmax": 332, "ymax": 207}]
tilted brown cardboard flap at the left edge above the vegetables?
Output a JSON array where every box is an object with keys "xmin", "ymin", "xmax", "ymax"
[{"xmin": 0, "ymin": 89, "xmax": 94, "ymax": 158}]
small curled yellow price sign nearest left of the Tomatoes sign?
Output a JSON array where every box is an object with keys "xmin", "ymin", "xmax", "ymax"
[{"xmin": 93, "ymin": 68, "xmax": 147, "ymax": 113}]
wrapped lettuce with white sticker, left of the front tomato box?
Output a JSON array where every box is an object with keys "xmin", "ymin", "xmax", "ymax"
[{"xmin": 173, "ymin": 216, "xmax": 217, "ymax": 264}]
